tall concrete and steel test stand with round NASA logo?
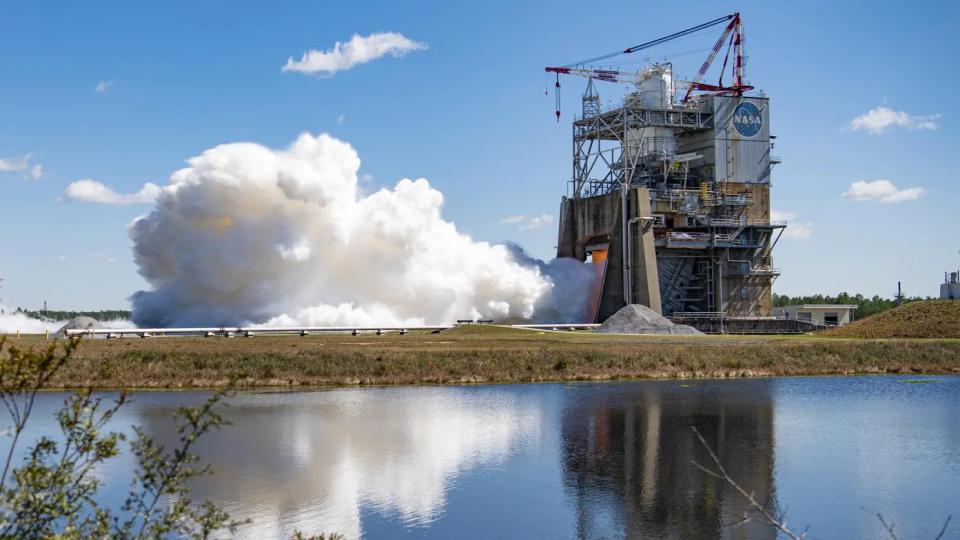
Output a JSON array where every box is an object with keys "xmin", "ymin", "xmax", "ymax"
[{"xmin": 546, "ymin": 14, "xmax": 786, "ymax": 328}]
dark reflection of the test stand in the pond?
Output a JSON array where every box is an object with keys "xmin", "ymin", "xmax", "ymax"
[{"xmin": 562, "ymin": 381, "xmax": 776, "ymax": 539}]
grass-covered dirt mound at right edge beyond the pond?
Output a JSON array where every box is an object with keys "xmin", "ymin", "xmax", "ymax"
[{"xmin": 822, "ymin": 300, "xmax": 960, "ymax": 338}]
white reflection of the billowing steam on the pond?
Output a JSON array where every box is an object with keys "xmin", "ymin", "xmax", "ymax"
[{"xmin": 140, "ymin": 388, "xmax": 540, "ymax": 538}]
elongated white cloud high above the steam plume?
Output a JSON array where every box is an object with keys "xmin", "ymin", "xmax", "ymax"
[{"xmin": 281, "ymin": 32, "xmax": 427, "ymax": 75}]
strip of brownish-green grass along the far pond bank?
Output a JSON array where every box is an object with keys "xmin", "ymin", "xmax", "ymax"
[{"xmin": 3, "ymin": 326, "xmax": 960, "ymax": 388}]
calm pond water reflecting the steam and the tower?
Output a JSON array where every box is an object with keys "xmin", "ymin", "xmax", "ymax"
[{"xmin": 9, "ymin": 376, "xmax": 960, "ymax": 539}]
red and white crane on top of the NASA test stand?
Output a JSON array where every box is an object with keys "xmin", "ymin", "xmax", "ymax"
[{"xmin": 545, "ymin": 12, "xmax": 753, "ymax": 122}]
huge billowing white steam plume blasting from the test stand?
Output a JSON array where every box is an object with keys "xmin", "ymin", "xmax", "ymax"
[{"xmin": 130, "ymin": 134, "xmax": 594, "ymax": 326}]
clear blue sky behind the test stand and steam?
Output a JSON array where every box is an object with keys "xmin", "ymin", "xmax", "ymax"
[{"xmin": 0, "ymin": 1, "xmax": 960, "ymax": 309}]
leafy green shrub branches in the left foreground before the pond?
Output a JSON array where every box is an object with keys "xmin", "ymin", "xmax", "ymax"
[{"xmin": 0, "ymin": 338, "xmax": 242, "ymax": 539}]
